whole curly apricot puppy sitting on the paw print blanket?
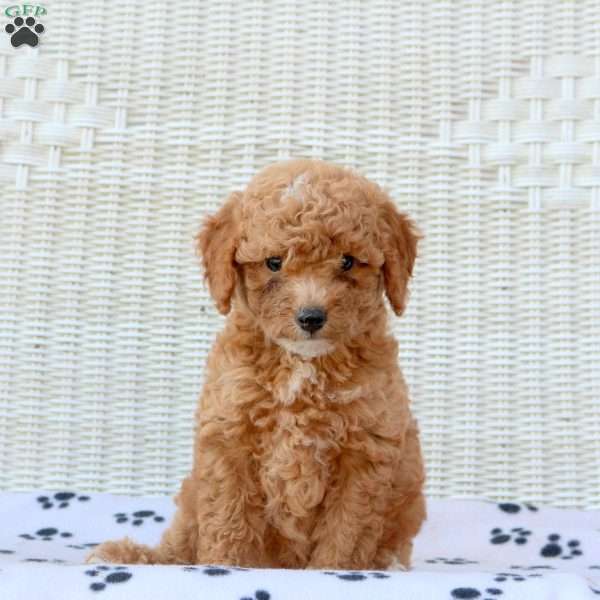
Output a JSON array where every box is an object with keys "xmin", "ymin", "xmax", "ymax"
[{"xmin": 89, "ymin": 160, "xmax": 425, "ymax": 569}]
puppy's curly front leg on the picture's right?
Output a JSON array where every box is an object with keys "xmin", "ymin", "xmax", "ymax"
[{"xmin": 308, "ymin": 452, "xmax": 393, "ymax": 569}]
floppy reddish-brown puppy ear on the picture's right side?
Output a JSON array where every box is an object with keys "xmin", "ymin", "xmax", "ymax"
[{"xmin": 382, "ymin": 200, "xmax": 422, "ymax": 316}]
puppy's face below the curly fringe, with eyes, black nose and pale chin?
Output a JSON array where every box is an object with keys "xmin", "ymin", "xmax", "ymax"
[{"xmin": 240, "ymin": 234, "xmax": 383, "ymax": 357}]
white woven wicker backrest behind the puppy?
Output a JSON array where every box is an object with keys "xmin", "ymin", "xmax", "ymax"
[{"xmin": 0, "ymin": 0, "xmax": 600, "ymax": 506}]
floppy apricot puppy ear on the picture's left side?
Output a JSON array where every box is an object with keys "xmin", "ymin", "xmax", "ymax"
[{"xmin": 198, "ymin": 192, "xmax": 242, "ymax": 315}]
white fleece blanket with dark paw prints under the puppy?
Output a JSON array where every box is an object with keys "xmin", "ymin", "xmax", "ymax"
[{"xmin": 0, "ymin": 491, "xmax": 600, "ymax": 600}]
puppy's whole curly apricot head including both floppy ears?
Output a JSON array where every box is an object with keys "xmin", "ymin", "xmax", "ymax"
[{"xmin": 199, "ymin": 160, "xmax": 419, "ymax": 357}]
